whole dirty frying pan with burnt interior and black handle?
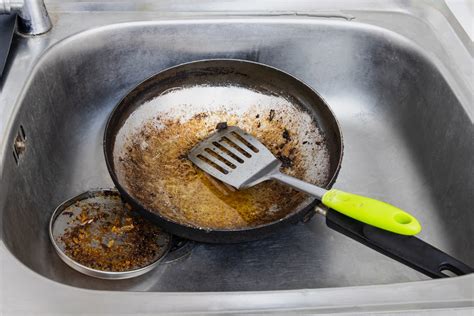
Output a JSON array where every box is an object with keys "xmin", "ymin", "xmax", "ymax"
[{"xmin": 104, "ymin": 60, "xmax": 473, "ymax": 278}]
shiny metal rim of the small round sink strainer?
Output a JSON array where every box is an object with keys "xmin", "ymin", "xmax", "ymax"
[{"xmin": 49, "ymin": 189, "xmax": 172, "ymax": 280}]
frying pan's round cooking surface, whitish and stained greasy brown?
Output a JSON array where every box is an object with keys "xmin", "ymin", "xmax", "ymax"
[{"xmin": 114, "ymin": 85, "xmax": 330, "ymax": 230}]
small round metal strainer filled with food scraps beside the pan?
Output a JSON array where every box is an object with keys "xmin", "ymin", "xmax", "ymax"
[{"xmin": 49, "ymin": 190, "xmax": 171, "ymax": 279}]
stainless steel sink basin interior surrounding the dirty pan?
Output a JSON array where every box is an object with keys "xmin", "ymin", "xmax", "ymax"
[{"xmin": 3, "ymin": 17, "xmax": 474, "ymax": 291}]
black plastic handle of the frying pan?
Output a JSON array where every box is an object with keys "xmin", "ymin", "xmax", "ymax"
[{"xmin": 326, "ymin": 210, "xmax": 474, "ymax": 278}]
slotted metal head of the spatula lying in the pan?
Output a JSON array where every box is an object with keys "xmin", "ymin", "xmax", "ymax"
[{"xmin": 188, "ymin": 126, "xmax": 281, "ymax": 189}]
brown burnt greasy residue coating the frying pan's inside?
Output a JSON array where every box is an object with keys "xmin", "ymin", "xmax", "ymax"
[{"xmin": 118, "ymin": 108, "xmax": 328, "ymax": 230}]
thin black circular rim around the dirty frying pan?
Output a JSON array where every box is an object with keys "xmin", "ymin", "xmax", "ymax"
[{"xmin": 103, "ymin": 58, "xmax": 344, "ymax": 243}]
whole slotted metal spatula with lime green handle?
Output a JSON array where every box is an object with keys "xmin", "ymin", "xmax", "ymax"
[{"xmin": 188, "ymin": 126, "xmax": 421, "ymax": 235}]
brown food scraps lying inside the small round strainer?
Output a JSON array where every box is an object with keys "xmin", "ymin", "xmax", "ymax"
[{"xmin": 56, "ymin": 195, "xmax": 168, "ymax": 272}]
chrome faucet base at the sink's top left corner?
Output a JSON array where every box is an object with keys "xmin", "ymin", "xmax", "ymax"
[{"xmin": 0, "ymin": 0, "xmax": 52, "ymax": 35}]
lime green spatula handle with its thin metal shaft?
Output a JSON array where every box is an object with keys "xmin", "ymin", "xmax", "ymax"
[{"xmin": 270, "ymin": 172, "xmax": 421, "ymax": 235}]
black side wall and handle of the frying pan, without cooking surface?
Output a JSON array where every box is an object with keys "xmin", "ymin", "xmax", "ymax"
[{"xmin": 104, "ymin": 60, "xmax": 473, "ymax": 278}]
